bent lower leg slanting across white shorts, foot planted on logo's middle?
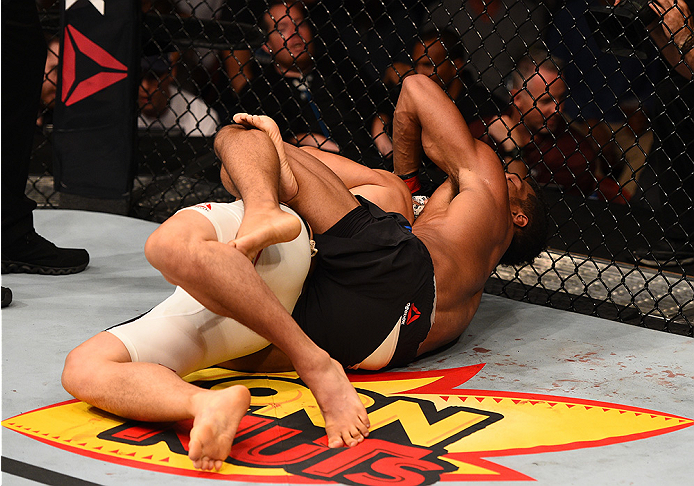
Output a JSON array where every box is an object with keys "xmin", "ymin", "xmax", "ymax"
[{"xmin": 145, "ymin": 191, "xmax": 368, "ymax": 447}]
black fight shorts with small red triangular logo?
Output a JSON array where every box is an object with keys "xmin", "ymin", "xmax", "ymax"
[{"xmin": 292, "ymin": 197, "xmax": 435, "ymax": 367}]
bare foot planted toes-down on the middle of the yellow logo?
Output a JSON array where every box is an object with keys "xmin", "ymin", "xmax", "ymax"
[{"xmin": 297, "ymin": 358, "xmax": 370, "ymax": 448}]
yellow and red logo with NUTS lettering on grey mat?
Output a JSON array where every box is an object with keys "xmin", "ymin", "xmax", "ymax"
[{"xmin": 2, "ymin": 365, "xmax": 694, "ymax": 485}]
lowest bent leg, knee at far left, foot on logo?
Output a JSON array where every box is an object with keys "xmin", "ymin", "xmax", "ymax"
[{"xmin": 62, "ymin": 332, "xmax": 250, "ymax": 470}]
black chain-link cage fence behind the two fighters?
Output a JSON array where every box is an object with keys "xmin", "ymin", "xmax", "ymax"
[{"xmin": 34, "ymin": 0, "xmax": 694, "ymax": 336}]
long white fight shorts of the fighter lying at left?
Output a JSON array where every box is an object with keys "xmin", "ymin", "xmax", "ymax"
[{"xmin": 108, "ymin": 201, "xmax": 311, "ymax": 376}]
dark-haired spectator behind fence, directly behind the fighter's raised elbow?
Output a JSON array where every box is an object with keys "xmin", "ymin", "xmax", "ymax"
[{"xmin": 371, "ymin": 28, "xmax": 506, "ymax": 163}]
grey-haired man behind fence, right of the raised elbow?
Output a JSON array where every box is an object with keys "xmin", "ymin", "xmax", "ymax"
[{"xmin": 471, "ymin": 48, "xmax": 616, "ymax": 197}]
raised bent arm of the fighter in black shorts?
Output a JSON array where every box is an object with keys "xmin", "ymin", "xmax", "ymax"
[{"xmin": 393, "ymin": 75, "xmax": 501, "ymax": 182}]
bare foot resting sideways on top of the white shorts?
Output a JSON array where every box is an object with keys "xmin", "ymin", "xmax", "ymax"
[{"xmin": 230, "ymin": 207, "xmax": 301, "ymax": 261}]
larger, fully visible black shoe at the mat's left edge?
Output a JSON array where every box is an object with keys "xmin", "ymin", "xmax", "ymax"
[{"xmin": 2, "ymin": 231, "xmax": 89, "ymax": 275}]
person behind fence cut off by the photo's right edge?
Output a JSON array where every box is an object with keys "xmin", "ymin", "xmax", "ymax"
[{"xmin": 634, "ymin": 0, "xmax": 694, "ymax": 267}]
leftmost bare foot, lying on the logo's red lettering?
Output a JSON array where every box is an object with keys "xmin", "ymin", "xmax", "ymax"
[{"xmin": 188, "ymin": 385, "xmax": 251, "ymax": 471}]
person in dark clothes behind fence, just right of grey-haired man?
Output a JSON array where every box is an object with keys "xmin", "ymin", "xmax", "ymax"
[{"xmin": 548, "ymin": 0, "xmax": 664, "ymax": 201}]
